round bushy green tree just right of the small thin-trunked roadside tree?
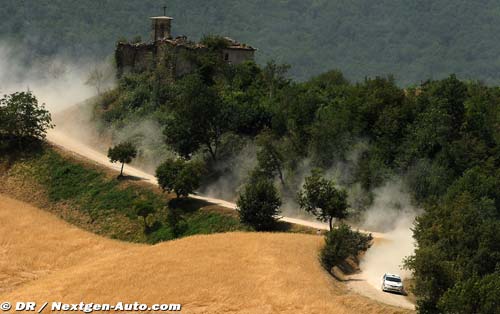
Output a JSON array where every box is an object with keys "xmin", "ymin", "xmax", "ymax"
[{"xmin": 156, "ymin": 159, "xmax": 203, "ymax": 198}]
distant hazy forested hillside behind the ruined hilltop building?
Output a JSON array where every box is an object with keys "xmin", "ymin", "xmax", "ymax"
[{"xmin": 4, "ymin": 0, "xmax": 500, "ymax": 86}]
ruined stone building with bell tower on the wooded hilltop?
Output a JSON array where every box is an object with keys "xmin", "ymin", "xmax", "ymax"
[{"xmin": 115, "ymin": 12, "xmax": 256, "ymax": 79}]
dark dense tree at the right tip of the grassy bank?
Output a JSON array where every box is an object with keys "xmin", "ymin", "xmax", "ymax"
[{"xmin": 236, "ymin": 176, "xmax": 281, "ymax": 231}]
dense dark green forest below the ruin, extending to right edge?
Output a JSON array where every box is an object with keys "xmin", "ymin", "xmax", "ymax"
[{"xmin": 92, "ymin": 39, "xmax": 500, "ymax": 313}]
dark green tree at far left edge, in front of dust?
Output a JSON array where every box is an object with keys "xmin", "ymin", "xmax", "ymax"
[{"xmin": 0, "ymin": 91, "xmax": 54, "ymax": 145}]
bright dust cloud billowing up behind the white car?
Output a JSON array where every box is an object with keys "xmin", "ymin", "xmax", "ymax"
[{"xmin": 282, "ymin": 144, "xmax": 421, "ymax": 289}]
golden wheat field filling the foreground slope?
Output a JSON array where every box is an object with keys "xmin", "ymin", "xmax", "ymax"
[{"xmin": 0, "ymin": 195, "xmax": 409, "ymax": 314}]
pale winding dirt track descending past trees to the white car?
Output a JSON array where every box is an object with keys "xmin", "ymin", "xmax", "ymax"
[{"xmin": 48, "ymin": 130, "xmax": 415, "ymax": 310}]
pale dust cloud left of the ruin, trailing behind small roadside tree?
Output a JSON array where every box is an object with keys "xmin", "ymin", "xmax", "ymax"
[{"xmin": 0, "ymin": 41, "xmax": 172, "ymax": 173}]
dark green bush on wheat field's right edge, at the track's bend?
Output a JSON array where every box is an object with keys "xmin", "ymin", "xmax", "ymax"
[{"xmin": 320, "ymin": 223, "xmax": 373, "ymax": 272}]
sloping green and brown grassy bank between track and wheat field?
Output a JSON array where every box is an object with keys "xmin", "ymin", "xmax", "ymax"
[{"xmin": 0, "ymin": 146, "xmax": 248, "ymax": 243}]
